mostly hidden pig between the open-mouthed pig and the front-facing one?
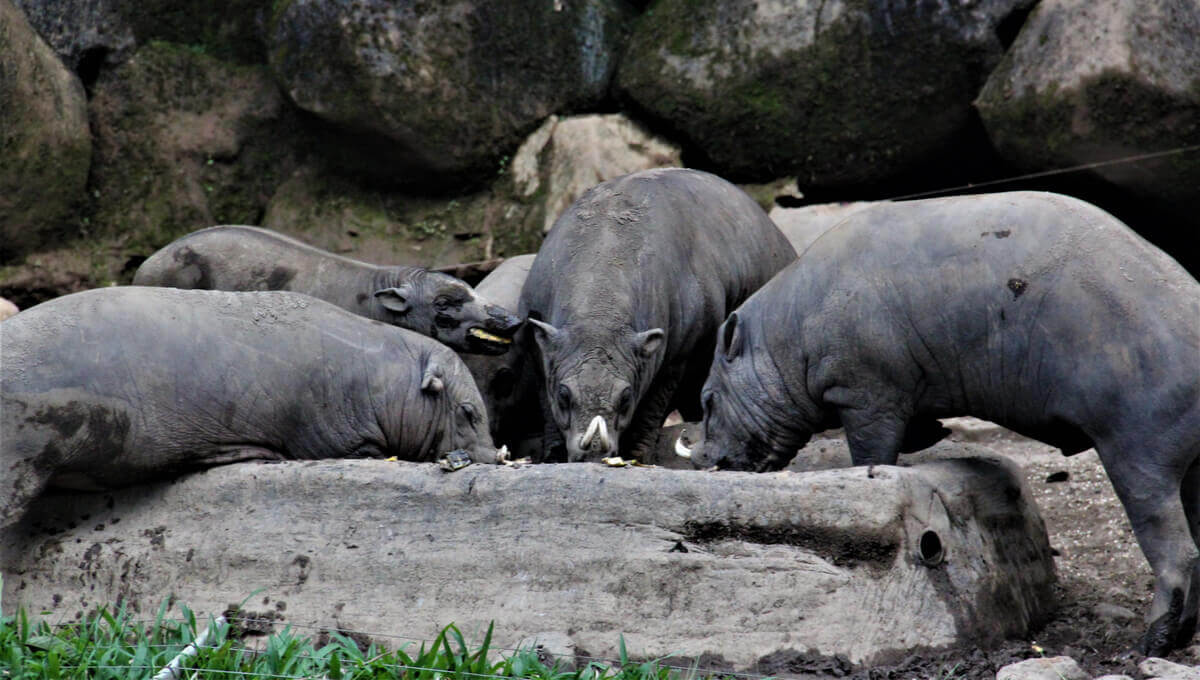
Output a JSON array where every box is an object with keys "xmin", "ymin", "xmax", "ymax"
[{"xmin": 462, "ymin": 254, "xmax": 542, "ymax": 451}]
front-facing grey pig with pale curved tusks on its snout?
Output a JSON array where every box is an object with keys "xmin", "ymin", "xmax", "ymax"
[{"xmin": 518, "ymin": 168, "xmax": 796, "ymax": 462}]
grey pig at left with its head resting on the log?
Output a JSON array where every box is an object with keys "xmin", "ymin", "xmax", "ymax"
[{"xmin": 0, "ymin": 287, "xmax": 497, "ymax": 526}]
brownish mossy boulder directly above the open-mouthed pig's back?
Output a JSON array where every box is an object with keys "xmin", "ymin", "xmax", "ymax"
[{"xmin": 90, "ymin": 42, "xmax": 305, "ymax": 254}]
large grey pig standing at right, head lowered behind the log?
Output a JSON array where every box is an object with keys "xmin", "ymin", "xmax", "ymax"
[{"xmin": 691, "ymin": 192, "xmax": 1200, "ymax": 656}]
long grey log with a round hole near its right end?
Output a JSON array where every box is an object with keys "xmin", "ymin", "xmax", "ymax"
[{"xmin": 0, "ymin": 450, "xmax": 1054, "ymax": 668}]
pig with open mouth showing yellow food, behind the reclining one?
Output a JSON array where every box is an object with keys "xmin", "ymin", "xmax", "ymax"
[{"xmin": 133, "ymin": 225, "xmax": 521, "ymax": 354}]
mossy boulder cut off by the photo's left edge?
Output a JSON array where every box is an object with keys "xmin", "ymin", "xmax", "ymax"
[{"xmin": 0, "ymin": 0, "xmax": 91, "ymax": 261}]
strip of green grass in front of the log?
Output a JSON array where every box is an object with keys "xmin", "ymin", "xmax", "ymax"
[{"xmin": 0, "ymin": 603, "xmax": 720, "ymax": 680}]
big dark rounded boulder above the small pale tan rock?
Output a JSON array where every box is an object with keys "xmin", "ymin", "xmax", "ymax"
[{"xmin": 268, "ymin": 0, "xmax": 634, "ymax": 183}]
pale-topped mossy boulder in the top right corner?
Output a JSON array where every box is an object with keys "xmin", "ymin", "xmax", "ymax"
[{"xmin": 976, "ymin": 0, "xmax": 1200, "ymax": 215}]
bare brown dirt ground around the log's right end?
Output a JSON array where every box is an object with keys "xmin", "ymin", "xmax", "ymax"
[{"xmin": 758, "ymin": 429, "xmax": 1200, "ymax": 680}]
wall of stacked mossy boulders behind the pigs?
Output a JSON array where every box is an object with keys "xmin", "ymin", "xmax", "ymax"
[{"xmin": 0, "ymin": 0, "xmax": 1200, "ymax": 301}]
